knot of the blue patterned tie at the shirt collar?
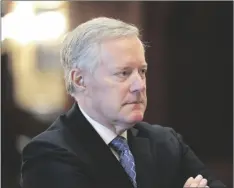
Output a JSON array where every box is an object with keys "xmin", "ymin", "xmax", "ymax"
[{"xmin": 110, "ymin": 136, "xmax": 129, "ymax": 154}]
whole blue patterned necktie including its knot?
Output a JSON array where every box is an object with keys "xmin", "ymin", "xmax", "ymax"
[{"xmin": 110, "ymin": 136, "xmax": 137, "ymax": 188}]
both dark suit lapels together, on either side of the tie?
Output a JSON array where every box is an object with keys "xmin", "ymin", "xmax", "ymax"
[{"xmin": 66, "ymin": 103, "xmax": 156, "ymax": 188}]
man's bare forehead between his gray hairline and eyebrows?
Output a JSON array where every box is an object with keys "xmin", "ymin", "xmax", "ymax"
[{"xmin": 101, "ymin": 36, "xmax": 146, "ymax": 67}]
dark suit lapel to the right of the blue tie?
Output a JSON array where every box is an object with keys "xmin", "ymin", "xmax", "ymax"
[{"xmin": 128, "ymin": 126, "xmax": 158, "ymax": 188}]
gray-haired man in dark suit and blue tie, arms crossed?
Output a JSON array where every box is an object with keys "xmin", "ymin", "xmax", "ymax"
[{"xmin": 22, "ymin": 17, "xmax": 225, "ymax": 188}]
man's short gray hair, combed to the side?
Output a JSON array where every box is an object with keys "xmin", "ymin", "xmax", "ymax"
[{"xmin": 60, "ymin": 17, "xmax": 143, "ymax": 95}]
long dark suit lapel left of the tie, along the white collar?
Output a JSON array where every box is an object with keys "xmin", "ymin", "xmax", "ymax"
[{"xmin": 66, "ymin": 104, "xmax": 133, "ymax": 188}]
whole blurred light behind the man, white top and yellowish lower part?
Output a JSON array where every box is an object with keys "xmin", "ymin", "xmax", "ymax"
[{"xmin": 1, "ymin": 1, "xmax": 69, "ymax": 120}]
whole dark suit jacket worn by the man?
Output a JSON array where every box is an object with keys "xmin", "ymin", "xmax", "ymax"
[{"xmin": 22, "ymin": 104, "xmax": 225, "ymax": 188}]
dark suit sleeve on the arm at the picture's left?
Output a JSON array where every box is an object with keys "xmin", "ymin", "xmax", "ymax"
[{"xmin": 21, "ymin": 141, "xmax": 95, "ymax": 188}]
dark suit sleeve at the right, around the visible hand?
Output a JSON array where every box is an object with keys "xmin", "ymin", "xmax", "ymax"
[{"xmin": 170, "ymin": 129, "xmax": 226, "ymax": 188}]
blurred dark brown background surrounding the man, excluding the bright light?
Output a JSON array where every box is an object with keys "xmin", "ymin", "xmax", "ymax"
[{"xmin": 1, "ymin": 1, "xmax": 233, "ymax": 188}]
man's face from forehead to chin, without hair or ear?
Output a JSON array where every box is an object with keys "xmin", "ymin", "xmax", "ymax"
[{"xmin": 83, "ymin": 37, "xmax": 147, "ymax": 128}]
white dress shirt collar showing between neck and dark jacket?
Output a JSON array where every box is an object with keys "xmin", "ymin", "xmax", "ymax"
[{"xmin": 78, "ymin": 105, "xmax": 127, "ymax": 160}]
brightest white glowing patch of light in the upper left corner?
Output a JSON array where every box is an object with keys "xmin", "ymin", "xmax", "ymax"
[{"xmin": 1, "ymin": 1, "xmax": 67, "ymax": 44}]
